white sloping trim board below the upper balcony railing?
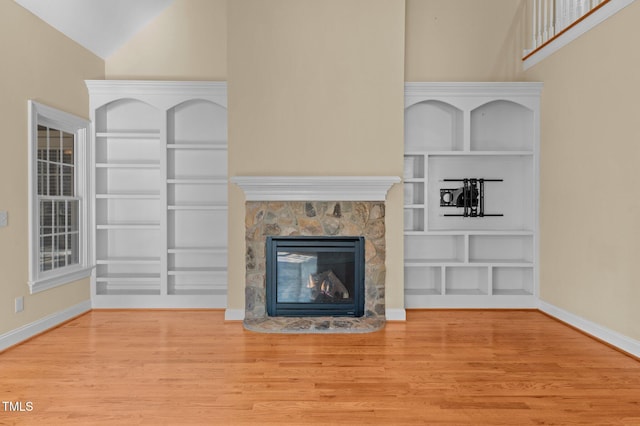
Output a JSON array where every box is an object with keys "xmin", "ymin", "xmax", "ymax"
[{"xmin": 522, "ymin": 0, "xmax": 636, "ymax": 71}]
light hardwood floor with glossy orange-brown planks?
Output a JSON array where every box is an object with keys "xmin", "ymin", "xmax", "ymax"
[{"xmin": 0, "ymin": 310, "xmax": 640, "ymax": 425}]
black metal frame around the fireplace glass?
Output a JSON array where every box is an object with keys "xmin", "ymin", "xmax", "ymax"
[{"xmin": 265, "ymin": 236, "xmax": 365, "ymax": 317}]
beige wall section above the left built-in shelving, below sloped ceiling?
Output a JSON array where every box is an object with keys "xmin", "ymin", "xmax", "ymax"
[{"xmin": 105, "ymin": 0, "xmax": 227, "ymax": 80}]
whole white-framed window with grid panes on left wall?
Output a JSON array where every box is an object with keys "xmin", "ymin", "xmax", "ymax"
[{"xmin": 29, "ymin": 101, "xmax": 91, "ymax": 293}]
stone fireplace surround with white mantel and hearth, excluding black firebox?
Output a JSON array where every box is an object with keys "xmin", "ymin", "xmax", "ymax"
[{"xmin": 231, "ymin": 176, "xmax": 400, "ymax": 333}]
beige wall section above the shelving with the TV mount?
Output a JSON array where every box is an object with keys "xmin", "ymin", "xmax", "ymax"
[{"xmin": 405, "ymin": 0, "xmax": 525, "ymax": 81}]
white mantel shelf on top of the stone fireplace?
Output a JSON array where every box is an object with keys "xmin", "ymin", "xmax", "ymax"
[{"xmin": 230, "ymin": 176, "xmax": 400, "ymax": 201}]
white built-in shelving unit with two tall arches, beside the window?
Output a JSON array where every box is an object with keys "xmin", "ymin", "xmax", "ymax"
[{"xmin": 87, "ymin": 81, "xmax": 228, "ymax": 308}]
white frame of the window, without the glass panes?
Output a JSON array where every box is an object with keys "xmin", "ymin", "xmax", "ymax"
[{"xmin": 28, "ymin": 100, "xmax": 93, "ymax": 294}]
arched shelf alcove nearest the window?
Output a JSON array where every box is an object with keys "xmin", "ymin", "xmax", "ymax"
[{"xmin": 92, "ymin": 97, "xmax": 162, "ymax": 296}]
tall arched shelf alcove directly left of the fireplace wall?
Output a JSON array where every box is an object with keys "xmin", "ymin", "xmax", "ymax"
[{"xmin": 167, "ymin": 98, "xmax": 228, "ymax": 296}]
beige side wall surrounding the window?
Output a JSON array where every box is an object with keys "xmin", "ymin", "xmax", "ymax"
[{"xmin": 0, "ymin": 1, "xmax": 104, "ymax": 334}]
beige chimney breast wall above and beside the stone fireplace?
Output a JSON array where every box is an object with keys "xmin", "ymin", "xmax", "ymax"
[{"xmin": 228, "ymin": 0, "xmax": 404, "ymax": 308}]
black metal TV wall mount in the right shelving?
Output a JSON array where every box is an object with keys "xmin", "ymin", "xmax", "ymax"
[{"xmin": 440, "ymin": 178, "xmax": 503, "ymax": 217}]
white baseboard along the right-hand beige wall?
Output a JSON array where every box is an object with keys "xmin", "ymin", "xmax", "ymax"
[{"xmin": 539, "ymin": 300, "xmax": 640, "ymax": 358}]
